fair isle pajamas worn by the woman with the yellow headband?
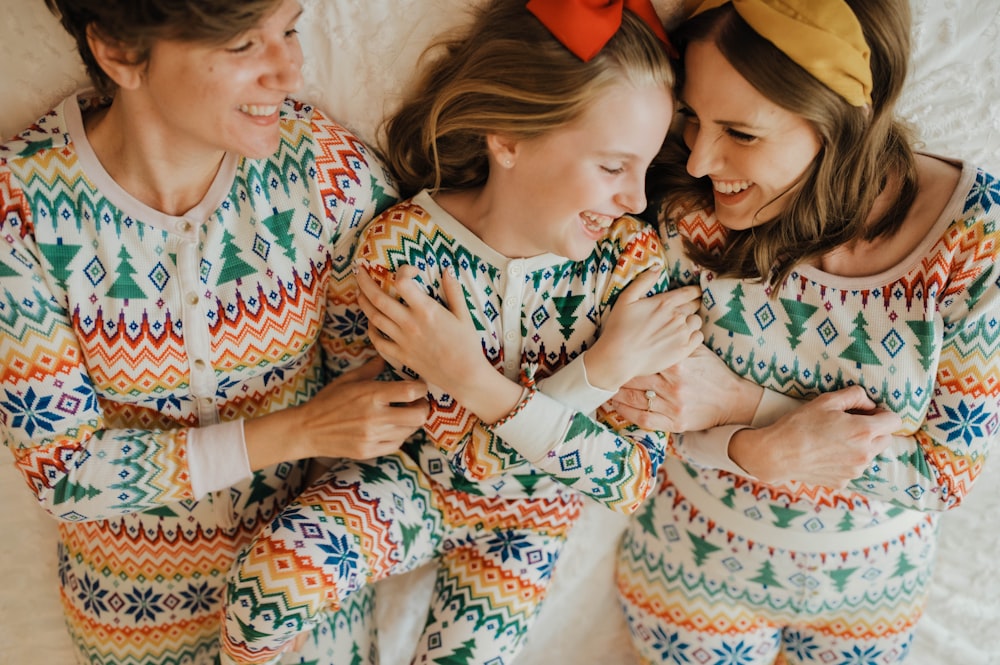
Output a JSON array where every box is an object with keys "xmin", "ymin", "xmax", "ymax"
[{"xmin": 617, "ymin": 166, "xmax": 1000, "ymax": 665}]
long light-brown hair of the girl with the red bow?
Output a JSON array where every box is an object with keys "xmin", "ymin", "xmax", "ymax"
[{"xmin": 380, "ymin": 0, "xmax": 674, "ymax": 197}]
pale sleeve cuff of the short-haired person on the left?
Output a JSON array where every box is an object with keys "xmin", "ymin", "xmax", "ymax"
[{"xmin": 188, "ymin": 420, "xmax": 253, "ymax": 499}]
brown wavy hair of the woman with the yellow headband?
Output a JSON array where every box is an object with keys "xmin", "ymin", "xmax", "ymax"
[{"xmin": 647, "ymin": 0, "xmax": 917, "ymax": 284}]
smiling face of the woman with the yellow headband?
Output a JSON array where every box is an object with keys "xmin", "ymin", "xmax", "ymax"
[{"xmin": 680, "ymin": 42, "xmax": 821, "ymax": 230}]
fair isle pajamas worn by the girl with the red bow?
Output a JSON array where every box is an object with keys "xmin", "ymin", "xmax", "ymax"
[{"xmin": 223, "ymin": 192, "xmax": 666, "ymax": 665}]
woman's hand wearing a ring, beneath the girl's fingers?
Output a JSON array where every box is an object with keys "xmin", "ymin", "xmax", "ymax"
[{"xmin": 610, "ymin": 344, "xmax": 764, "ymax": 432}]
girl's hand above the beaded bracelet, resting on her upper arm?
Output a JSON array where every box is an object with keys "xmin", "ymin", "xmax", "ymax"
[{"xmin": 357, "ymin": 266, "xmax": 521, "ymax": 422}]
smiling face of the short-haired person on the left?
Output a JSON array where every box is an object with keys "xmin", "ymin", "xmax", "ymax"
[{"xmin": 135, "ymin": 0, "xmax": 302, "ymax": 158}]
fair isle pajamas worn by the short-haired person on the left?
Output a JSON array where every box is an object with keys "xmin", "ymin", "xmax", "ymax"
[{"xmin": 0, "ymin": 92, "xmax": 395, "ymax": 665}]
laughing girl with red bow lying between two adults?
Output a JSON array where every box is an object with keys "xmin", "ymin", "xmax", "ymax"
[{"xmin": 223, "ymin": 0, "xmax": 702, "ymax": 664}]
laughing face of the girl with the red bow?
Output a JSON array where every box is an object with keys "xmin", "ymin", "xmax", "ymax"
[{"xmin": 491, "ymin": 83, "xmax": 673, "ymax": 261}]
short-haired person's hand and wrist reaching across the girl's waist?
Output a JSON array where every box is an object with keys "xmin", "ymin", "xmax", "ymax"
[{"xmin": 244, "ymin": 358, "xmax": 428, "ymax": 469}]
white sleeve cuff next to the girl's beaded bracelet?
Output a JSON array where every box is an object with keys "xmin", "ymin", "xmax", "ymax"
[{"xmin": 490, "ymin": 390, "xmax": 576, "ymax": 464}]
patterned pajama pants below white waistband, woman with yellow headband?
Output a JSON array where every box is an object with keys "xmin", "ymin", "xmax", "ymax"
[{"xmin": 616, "ymin": 466, "xmax": 936, "ymax": 665}]
